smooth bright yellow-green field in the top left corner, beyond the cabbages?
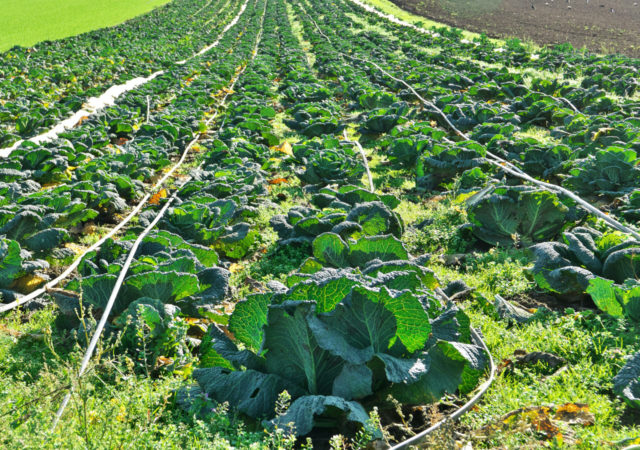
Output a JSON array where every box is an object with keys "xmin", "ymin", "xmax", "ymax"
[{"xmin": 0, "ymin": 0, "xmax": 170, "ymax": 51}]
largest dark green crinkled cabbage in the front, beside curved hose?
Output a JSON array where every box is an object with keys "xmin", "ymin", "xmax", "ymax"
[{"xmin": 194, "ymin": 268, "xmax": 486, "ymax": 435}]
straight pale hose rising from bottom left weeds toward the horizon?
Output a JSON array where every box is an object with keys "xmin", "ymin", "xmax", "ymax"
[{"xmin": 51, "ymin": 0, "xmax": 268, "ymax": 432}]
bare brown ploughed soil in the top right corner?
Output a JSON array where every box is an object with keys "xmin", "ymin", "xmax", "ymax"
[{"xmin": 392, "ymin": 0, "xmax": 640, "ymax": 57}]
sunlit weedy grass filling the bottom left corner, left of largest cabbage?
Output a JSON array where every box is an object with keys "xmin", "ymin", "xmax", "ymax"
[{"xmin": 0, "ymin": 307, "xmax": 269, "ymax": 449}]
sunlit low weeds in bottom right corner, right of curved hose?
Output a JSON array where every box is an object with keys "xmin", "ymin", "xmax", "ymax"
[{"xmin": 462, "ymin": 305, "xmax": 640, "ymax": 448}]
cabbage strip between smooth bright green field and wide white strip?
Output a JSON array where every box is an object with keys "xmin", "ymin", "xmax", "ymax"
[{"xmin": 0, "ymin": 0, "xmax": 242, "ymax": 147}]
